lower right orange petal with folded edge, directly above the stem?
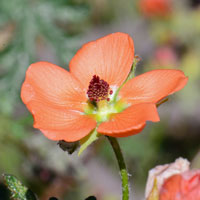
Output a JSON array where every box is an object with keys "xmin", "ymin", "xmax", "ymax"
[{"xmin": 97, "ymin": 104, "xmax": 159, "ymax": 137}]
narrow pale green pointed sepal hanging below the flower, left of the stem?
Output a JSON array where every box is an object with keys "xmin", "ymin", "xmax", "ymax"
[{"xmin": 78, "ymin": 128, "xmax": 99, "ymax": 156}]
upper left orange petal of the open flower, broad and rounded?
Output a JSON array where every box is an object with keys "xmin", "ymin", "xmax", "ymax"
[{"xmin": 21, "ymin": 62, "xmax": 87, "ymax": 111}]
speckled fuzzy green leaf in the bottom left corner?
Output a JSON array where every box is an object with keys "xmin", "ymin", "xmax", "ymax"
[{"xmin": 3, "ymin": 174, "xmax": 37, "ymax": 200}]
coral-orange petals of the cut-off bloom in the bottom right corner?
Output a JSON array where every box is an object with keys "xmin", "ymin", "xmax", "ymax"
[{"xmin": 159, "ymin": 170, "xmax": 200, "ymax": 200}]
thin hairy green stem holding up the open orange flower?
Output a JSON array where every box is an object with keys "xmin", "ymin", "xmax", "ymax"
[{"xmin": 107, "ymin": 136, "xmax": 129, "ymax": 200}]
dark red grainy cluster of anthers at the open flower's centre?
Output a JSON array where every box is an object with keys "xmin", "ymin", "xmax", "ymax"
[{"xmin": 87, "ymin": 75, "xmax": 113, "ymax": 102}]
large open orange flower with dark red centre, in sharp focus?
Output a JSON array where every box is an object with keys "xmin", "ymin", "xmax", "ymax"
[{"xmin": 21, "ymin": 33, "xmax": 187, "ymax": 142}]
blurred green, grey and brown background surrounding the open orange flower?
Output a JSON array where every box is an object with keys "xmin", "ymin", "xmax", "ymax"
[{"xmin": 0, "ymin": 0, "xmax": 200, "ymax": 200}]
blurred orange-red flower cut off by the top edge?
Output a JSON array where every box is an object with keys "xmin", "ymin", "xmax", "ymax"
[{"xmin": 139, "ymin": 0, "xmax": 172, "ymax": 17}]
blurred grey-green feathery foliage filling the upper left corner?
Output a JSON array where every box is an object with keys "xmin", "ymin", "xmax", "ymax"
[{"xmin": 0, "ymin": 0, "xmax": 88, "ymax": 113}]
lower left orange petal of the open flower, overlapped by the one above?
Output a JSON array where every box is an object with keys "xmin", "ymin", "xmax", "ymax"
[{"xmin": 27, "ymin": 101, "xmax": 96, "ymax": 142}]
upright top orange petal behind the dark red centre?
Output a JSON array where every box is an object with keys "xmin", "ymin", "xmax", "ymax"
[{"xmin": 69, "ymin": 33, "xmax": 134, "ymax": 88}]
